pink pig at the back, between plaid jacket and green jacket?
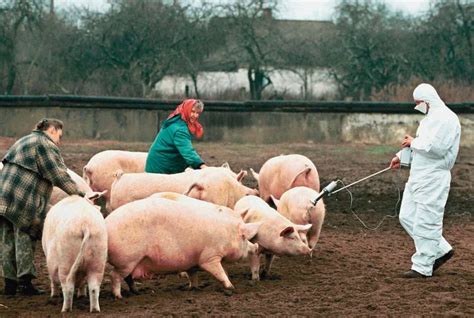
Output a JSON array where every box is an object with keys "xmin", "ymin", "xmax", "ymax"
[{"xmin": 82, "ymin": 150, "xmax": 148, "ymax": 212}]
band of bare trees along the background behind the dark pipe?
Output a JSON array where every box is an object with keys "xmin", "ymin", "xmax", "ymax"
[{"xmin": 0, "ymin": 0, "xmax": 474, "ymax": 102}]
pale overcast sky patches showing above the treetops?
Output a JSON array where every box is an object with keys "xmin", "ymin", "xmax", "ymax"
[{"xmin": 55, "ymin": 0, "xmax": 430, "ymax": 20}]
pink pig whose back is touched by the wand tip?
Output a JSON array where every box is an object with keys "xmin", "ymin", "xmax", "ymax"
[{"xmin": 272, "ymin": 187, "xmax": 326, "ymax": 249}]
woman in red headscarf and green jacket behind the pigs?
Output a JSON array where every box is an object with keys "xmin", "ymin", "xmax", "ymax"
[{"xmin": 145, "ymin": 99, "xmax": 206, "ymax": 174}]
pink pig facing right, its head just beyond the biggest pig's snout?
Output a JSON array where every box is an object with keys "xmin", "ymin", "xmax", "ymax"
[{"xmin": 234, "ymin": 196, "xmax": 312, "ymax": 280}]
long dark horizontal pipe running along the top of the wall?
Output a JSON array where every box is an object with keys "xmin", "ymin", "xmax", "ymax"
[{"xmin": 0, "ymin": 95, "xmax": 474, "ymax": 114}]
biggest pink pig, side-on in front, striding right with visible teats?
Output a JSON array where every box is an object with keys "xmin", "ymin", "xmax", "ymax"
[{"xmin": 105, "ymin": 197, "xmax": 259, "ymax": 298}]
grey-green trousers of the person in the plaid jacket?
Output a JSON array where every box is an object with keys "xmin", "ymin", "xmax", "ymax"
[{"xmin": 0, "ymin": 217, "xmax": 36, "ymax": 280}]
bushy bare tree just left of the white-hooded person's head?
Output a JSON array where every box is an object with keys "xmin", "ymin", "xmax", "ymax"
[{"xmin": 324, "ymin": 1, "xmax": 410, "ymax": 100}]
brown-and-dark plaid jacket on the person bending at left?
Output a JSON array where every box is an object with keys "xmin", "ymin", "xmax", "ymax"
[{"xmin": 0, "ymin": 130, "xmax": 84, "ymax": 239}]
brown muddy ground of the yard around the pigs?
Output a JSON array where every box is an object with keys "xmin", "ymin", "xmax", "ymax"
[{"xmin": 0, "ymin": 138, "xmax": 474, "ymax": 317}]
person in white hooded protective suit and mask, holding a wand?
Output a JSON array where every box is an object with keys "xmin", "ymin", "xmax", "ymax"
[{"xmin": 390, "ymin": 84, "xmax": 461, "ymax": 278}]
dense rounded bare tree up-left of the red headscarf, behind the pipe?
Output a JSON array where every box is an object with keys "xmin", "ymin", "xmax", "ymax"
[{"xmin": 82, "ymin": 0, "xmax": 190, "ymax": 96}]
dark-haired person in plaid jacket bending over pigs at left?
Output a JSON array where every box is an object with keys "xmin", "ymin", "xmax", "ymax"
[{"xmin": 0, "ymin": 119, "xmax": 85, "ymax": 295}]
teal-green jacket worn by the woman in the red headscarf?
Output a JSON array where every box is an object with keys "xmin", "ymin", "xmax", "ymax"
[{"xmin": 145, "ymin": 115, "xmax": 204, "ymax": 174}]
